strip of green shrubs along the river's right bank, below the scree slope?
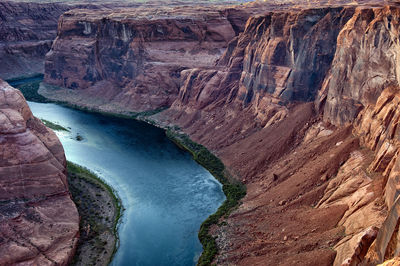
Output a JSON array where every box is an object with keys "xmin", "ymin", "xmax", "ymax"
[{"xmin": 166, "ymin": 130, "xmax": 246, "ymax": 266}]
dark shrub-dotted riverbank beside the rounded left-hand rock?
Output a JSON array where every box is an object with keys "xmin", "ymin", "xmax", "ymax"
[{"xmin": 68, "ymin": 162, "xmax": 121, "ymax": 265}]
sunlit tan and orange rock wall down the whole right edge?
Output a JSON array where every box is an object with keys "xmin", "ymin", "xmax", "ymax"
[{"xmin": 316, "ymin": 6, "xmax": 400, "ymax": 264}]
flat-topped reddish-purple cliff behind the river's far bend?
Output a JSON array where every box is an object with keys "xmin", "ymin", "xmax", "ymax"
[{"xmin": 45, "ymin": 6, "xmax": 247, "ymax": 111}]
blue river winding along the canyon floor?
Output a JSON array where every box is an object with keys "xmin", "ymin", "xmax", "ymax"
[{"xmin": 28, "ymin": 102, "xmax": 225, "ymax": 266}]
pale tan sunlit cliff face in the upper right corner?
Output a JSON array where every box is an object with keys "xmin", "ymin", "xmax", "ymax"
[{"xmin": 318, "ymin": 6, "xmax": 400, "ymax": 125}]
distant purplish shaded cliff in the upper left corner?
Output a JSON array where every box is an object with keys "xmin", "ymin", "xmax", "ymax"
[{"xmin": 0, "ymin": 1, "xmax": 68, "ymax": 79}]
